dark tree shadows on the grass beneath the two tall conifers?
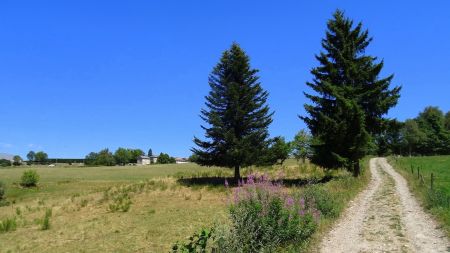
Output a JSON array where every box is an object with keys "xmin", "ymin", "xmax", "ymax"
[{"xmin": 177, "ymin": 176, "xmax": 333, "ymax": 187}]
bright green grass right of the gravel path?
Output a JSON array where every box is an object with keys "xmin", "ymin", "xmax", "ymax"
[{"xmin": 389, "ymin": 156, "xmax": 450, "ymax": 236}]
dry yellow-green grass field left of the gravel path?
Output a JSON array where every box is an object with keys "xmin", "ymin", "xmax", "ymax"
[{"xmin": 0, "ymin": 160, "xmax": 368, "ymax": 252}]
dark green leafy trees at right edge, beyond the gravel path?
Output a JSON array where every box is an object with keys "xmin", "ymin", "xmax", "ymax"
[{"xmin": 376, "ymin": 106, "xmax": 450, "ymax": 156}]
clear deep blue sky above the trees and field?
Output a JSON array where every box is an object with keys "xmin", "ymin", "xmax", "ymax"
[{"xmin": 0, "ymin": 0, "xmax": 450, "ymax": 157}]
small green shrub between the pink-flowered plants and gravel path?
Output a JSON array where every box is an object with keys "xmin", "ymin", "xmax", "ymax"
[{"xmin": 302, "ymin": 185, "xmax": 339, "ymax": 218}]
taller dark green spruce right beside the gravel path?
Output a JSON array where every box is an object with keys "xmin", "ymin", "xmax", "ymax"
[{"xmin": 300, "ymin": 10, "xmax": 401, "ymax": 176}]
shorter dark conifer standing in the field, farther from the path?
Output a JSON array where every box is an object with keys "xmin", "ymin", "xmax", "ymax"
[{"xmin": 192, "ymin": 43, "xmax": 273, "ymax": 179}]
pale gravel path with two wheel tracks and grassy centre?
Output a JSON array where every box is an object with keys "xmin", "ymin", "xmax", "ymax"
[{"xmin": 320, "ymin": 158, "xmax": 450, "ymax": 253}]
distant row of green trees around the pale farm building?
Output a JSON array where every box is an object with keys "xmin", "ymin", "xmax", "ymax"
[{"xmin": 84, "ymin": 148, "xmax": 175, "ymax": 166}]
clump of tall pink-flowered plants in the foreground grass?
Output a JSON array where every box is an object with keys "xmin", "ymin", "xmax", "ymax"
[{"xmin": 219, "ymin": 175, "xmax": 320, "ymax": 252}]
